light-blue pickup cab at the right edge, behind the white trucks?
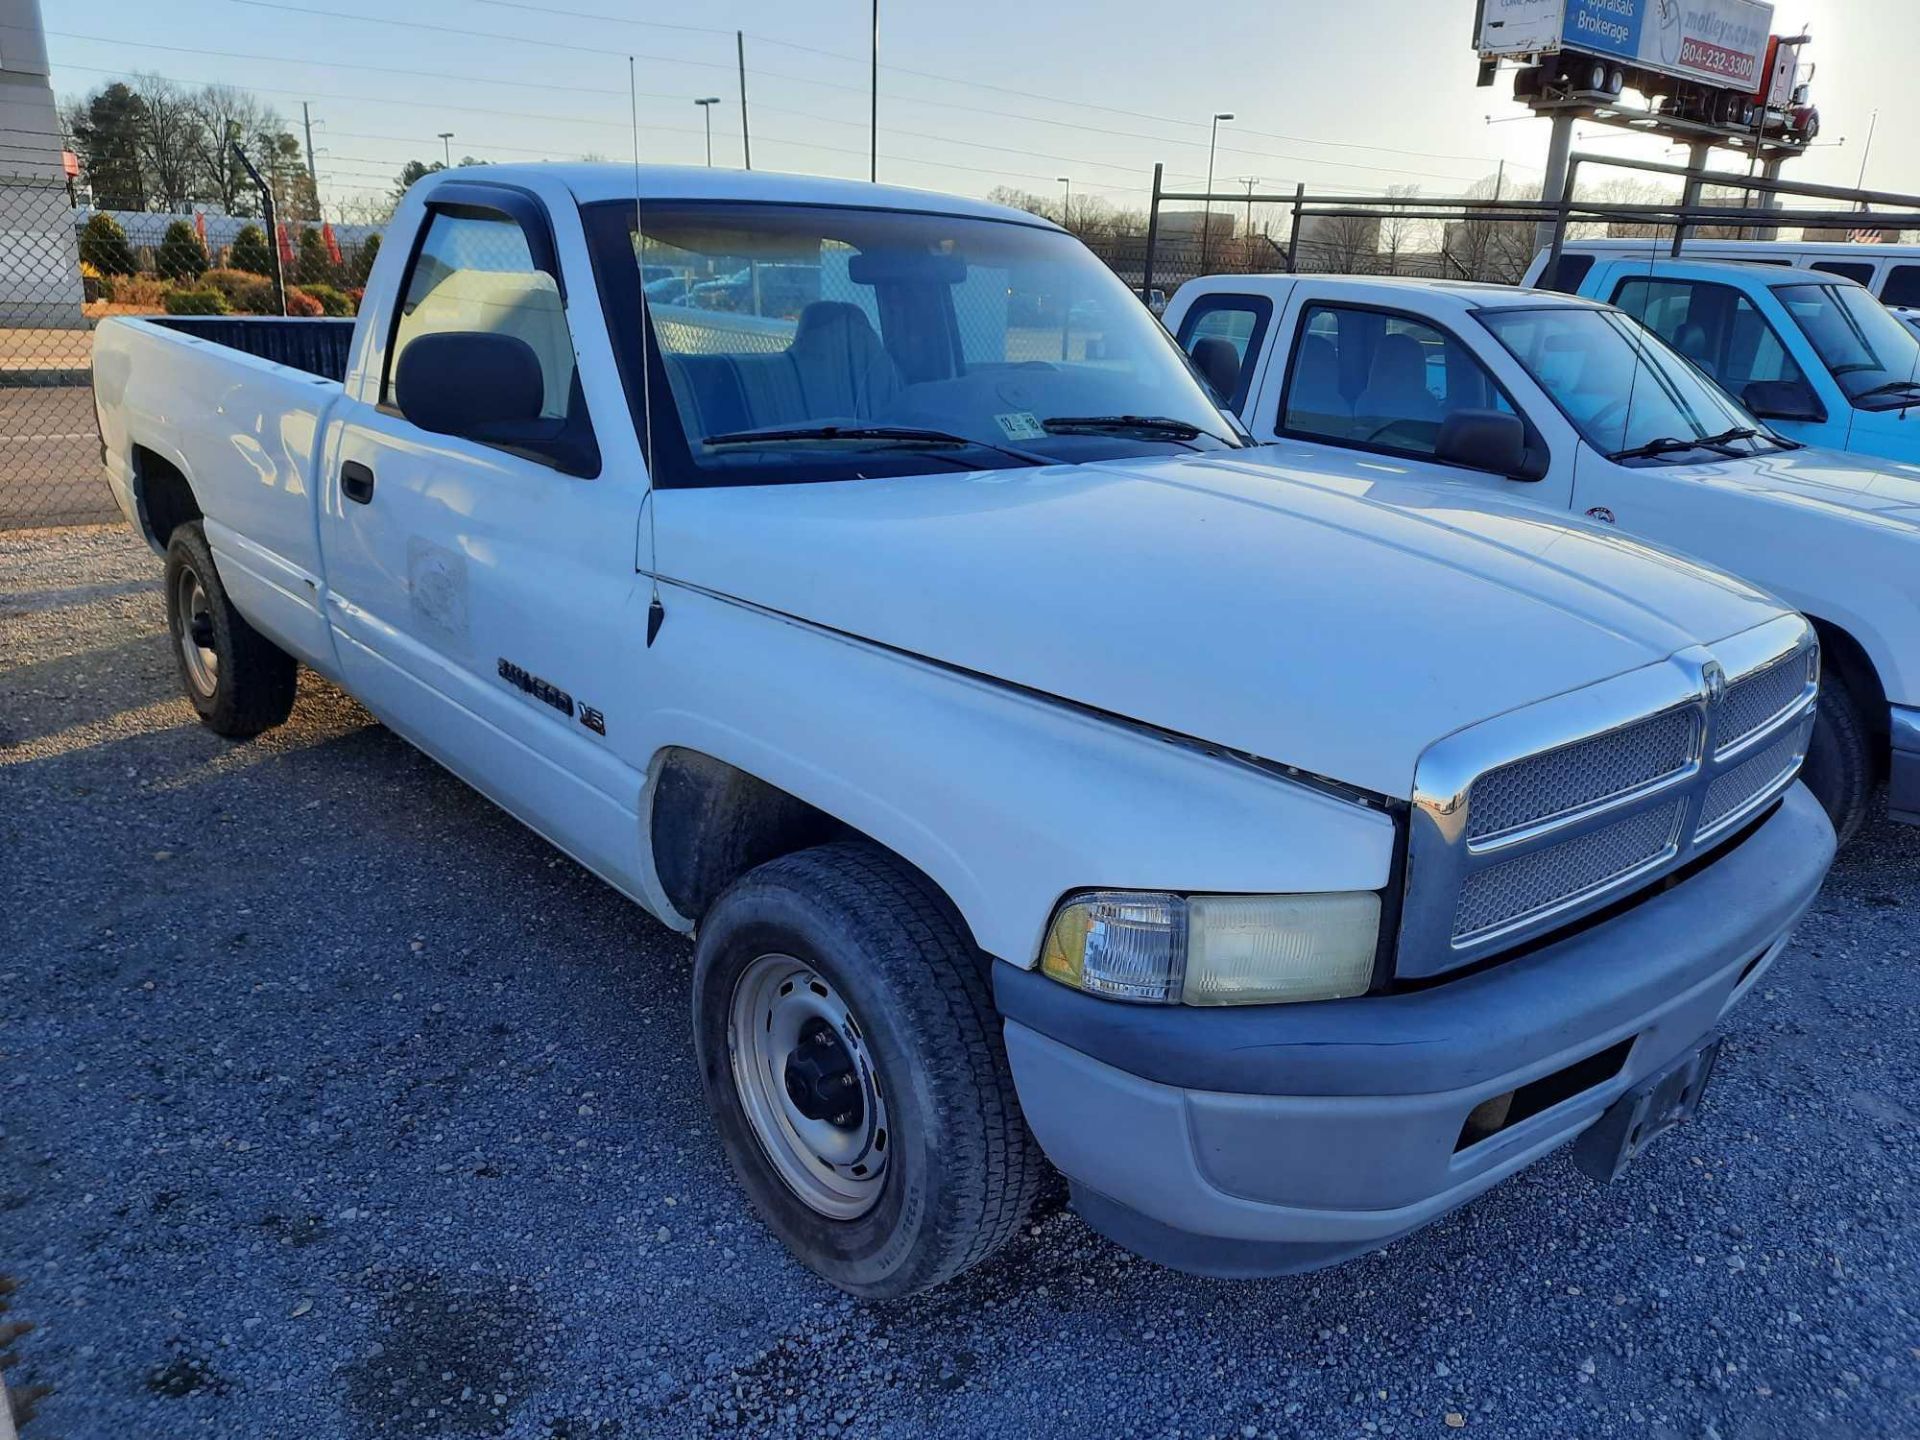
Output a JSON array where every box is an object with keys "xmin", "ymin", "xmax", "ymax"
[{"xmin": 1578, "ymin": 257, "xmax": 1920, "ymax": 463}]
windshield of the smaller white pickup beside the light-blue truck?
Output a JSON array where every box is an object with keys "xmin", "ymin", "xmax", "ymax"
[{"xmin": 1478, "ymin": 305, "xmax": 1782, "ymax": 463}]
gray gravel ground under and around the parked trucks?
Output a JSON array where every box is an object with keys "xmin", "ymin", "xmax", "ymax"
[{"xmin": 11, "ymin": 530, "xmax": 1920, "ymax": 1440}]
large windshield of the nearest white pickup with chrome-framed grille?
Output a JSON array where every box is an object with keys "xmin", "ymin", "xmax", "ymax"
[{"xmin": 588, "ymin": 202, "xmax": 1246, "ymax": 486}]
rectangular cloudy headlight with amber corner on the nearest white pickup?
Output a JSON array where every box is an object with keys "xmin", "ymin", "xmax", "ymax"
[{"xmin": 1041, "ymin": 891, "xmax": 1380, "ymax": 1004}]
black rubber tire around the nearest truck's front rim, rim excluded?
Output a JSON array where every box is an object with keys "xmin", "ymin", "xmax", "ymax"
[{"xmin": 693, "ymin": 843, "xmax": 1048, "ymax": 1300}]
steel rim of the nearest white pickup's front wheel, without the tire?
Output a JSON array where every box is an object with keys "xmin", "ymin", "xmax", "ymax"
[{"xmin": 728, "ymin": 954, "xmax": 891, "ymax": 1219}]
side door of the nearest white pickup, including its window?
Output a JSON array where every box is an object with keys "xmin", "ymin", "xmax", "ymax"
[{"xmin": 321, "ymin": 182, "xmax": 647, "ymax": 883}]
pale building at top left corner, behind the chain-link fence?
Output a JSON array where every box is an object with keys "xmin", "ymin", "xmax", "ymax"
[{"xmin": 0, "ymin": 0, "xmax": 86, "ymax": 328}]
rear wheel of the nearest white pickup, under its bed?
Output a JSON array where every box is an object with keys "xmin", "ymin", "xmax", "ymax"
[{"xmin": 165, "ymin": 520, "xmax": 300, "ymax": 739}]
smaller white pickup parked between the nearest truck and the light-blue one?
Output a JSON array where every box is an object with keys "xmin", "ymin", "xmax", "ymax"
[{"xmin": 1167, "ymin": 272, "xmax": 1920, "ymax": 841}]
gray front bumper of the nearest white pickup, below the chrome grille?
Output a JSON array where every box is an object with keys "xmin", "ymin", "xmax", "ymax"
[{"xmin": 995, "ymin": 785, "xmax": 1834, "ymax": 1275}]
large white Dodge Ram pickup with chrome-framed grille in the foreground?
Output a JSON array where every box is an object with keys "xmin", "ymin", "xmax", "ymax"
[{"xmin": 94, "ymin": 165, "xmax": 1834, "ymax": 1296}]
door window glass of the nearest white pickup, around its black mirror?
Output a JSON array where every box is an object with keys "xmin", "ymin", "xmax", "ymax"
[{"xmin": 380, "ymin": 211, "xmax": 580, "ymax": 420}]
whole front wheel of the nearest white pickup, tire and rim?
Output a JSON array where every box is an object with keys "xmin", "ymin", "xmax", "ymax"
[{"xmin": 693, "ymin": 843, "xmax": 1046, "ymax": 1300}]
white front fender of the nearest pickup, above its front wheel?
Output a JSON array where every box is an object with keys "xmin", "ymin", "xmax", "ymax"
[{"xmin": 643, "ymin": 588, "xmax": 1394, "ymax": 968}]
